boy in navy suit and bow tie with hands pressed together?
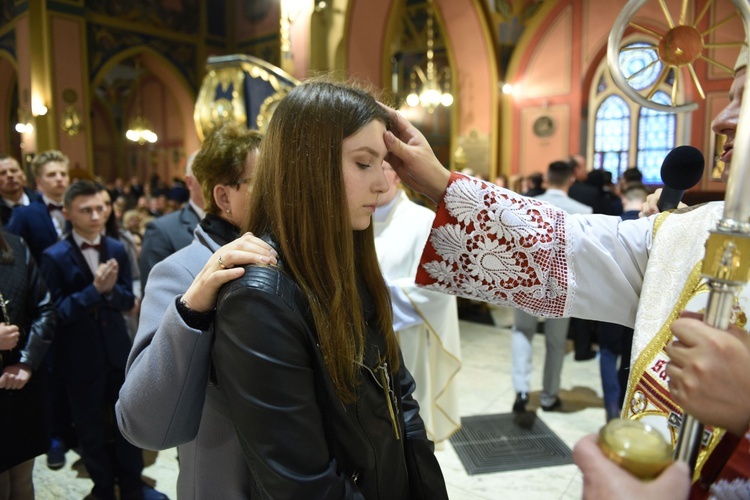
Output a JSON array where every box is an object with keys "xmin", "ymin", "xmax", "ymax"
[{"xmin": 41, "ymin": 181, "xmax": 165, "ymax": 499}]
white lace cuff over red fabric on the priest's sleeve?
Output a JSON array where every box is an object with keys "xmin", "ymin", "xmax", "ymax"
[{"xmin": 418, "ymin": 174, "xmax": 574, "ymax": 316}]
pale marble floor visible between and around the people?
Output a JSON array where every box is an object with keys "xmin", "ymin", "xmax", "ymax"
[{"xmin": 34, "ymin": 309, "xmax": 605, "ymax": 500}]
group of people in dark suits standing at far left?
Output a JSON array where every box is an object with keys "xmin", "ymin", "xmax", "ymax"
[{"xmin": 0, "ymin": 150, "xmax": 171, "ymax": 500}]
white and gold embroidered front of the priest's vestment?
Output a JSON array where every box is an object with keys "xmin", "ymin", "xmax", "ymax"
[{"xmin": 623, "ymin": 203, "xmax": 747, "ymax": 477}]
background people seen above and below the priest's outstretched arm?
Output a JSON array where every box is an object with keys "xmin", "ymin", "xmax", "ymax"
[{"xmin": 488, "ymin": 161, "xmax": 652, "ymax": 420}]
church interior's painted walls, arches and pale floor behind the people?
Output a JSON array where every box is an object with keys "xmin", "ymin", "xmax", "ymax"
[{"xmin": 0, "ymin": 0, "xmax": 745, "ymax": 500}]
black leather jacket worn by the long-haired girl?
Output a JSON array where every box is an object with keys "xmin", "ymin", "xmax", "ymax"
[{"xmin": 213, "ymin": 247, "xmax": 448, "ymax": 500}]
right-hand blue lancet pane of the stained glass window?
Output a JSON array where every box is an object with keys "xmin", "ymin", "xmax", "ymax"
[{"xmin": 638, "ymin": 91, "xmax": 677, "ymax": 183}]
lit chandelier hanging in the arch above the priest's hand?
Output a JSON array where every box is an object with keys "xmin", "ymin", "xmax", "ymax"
[{"xmin": 406, "ymin": 0, "xmax": 453, "ymax": 113}]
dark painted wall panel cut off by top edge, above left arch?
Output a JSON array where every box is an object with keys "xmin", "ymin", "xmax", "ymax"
[{"xmin": 86, "ymin": 0, "xmax": 200, "ymax": 34}]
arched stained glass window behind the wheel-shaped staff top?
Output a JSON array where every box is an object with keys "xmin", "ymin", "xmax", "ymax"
[{"xmin": 588, "ymin": 41, "xmax": 682, "ymax": 184}]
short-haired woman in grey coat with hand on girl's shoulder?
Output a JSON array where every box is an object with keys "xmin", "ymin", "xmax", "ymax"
[{"xmin": 116, "ymin": 123, "xmax": 275, "ymax": 498}]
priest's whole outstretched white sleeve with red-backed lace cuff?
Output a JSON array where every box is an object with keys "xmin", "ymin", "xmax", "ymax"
[{"xmin": 417, "ymin": 173, "xmax": 650, "ymax": 324}]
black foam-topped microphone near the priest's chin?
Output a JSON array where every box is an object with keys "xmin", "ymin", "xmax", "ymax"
[{"xmin": 656, "ymin": 146, "xmax": 706, "ymax": 212}]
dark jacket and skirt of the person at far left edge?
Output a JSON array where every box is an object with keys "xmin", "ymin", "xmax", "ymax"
[{"xmin": 0, "ymin": 232, "xmax": 56, "ymax": 472}]
